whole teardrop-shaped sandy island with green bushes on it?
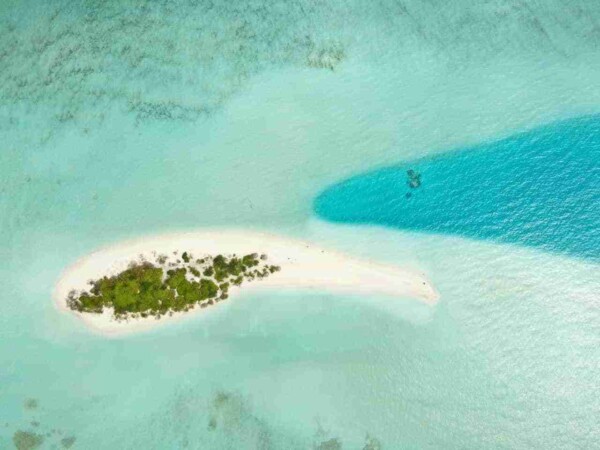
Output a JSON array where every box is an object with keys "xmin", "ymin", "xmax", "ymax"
[{"xmin": 52, "ymin": 229, "xmax": 439, "ymax": 337}]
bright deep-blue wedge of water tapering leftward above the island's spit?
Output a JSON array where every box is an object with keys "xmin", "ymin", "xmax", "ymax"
[{"xmin": 315, "ymin": 116, "xmax": 600, "ymax": 260}]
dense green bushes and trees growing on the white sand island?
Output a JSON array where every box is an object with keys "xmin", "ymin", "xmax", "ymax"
[{"xmin": 67, "ymin": 252, "xmax": 280, "ymax": 319}]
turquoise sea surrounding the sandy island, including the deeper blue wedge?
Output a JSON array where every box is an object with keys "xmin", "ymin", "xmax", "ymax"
[{"xmin": 0, "ymin": 0, "xmax": 600, "ymax": 449}]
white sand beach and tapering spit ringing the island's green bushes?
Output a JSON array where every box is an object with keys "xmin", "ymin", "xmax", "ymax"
[{"xmin": 53, "ymin": 230, "xmax": 439, "ymax": 336}]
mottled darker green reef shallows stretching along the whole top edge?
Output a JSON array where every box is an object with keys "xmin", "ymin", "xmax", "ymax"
[{"xmin": 0, "ymin": 0, "xmax": 600, "ymax": 143}]
